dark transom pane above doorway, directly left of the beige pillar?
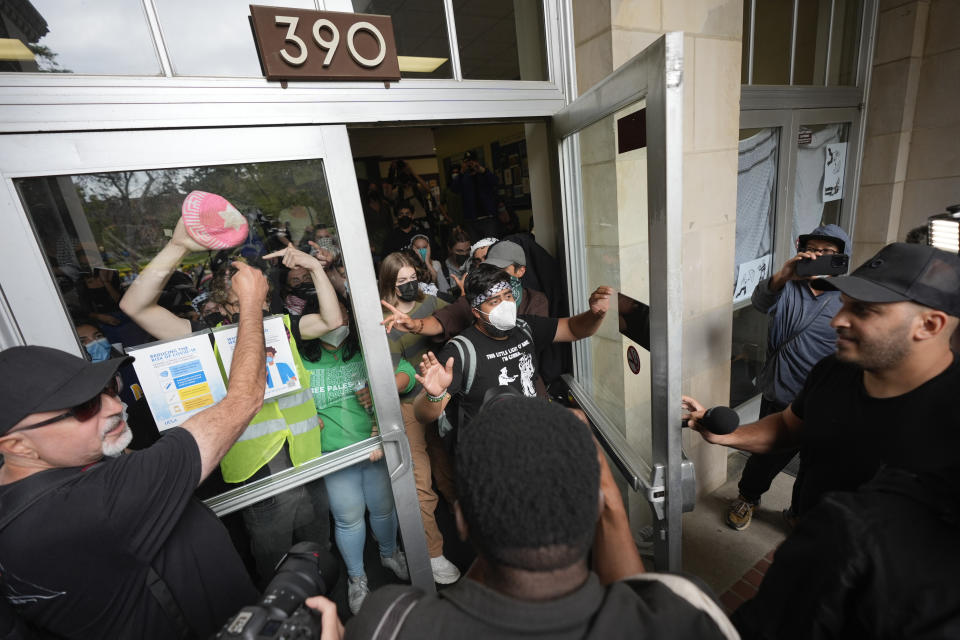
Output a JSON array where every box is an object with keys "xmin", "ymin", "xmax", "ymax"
[{"xmin": 453, "ymin": 0, "xmax": 548, "ymax": 80}]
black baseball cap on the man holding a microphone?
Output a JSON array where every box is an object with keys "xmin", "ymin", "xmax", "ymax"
[{"xmin": 810, "ymin": 242, "xmax": 960, "ymax": 317}]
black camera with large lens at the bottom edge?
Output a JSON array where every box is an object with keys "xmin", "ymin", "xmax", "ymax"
[{"xmin": 214, "ymin": 542, "xmax": 340, "ymax": 640}]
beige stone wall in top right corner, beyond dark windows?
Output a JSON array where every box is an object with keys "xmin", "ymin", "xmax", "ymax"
[{"xmin": 853, "ymin": 0, "xmax": 960, "ymax": 264}]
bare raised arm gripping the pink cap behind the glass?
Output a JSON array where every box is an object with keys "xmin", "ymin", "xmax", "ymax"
[{"xmin": 120, "ymin": 220, "xmax": 206, "ymax": 340}]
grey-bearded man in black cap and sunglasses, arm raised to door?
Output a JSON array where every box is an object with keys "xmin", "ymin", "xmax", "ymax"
[{"xmin": 0, "ymin": 263, "xmax": 268, "ymax": 639}]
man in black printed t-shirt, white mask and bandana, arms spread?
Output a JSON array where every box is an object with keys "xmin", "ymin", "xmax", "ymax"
[{"xmin": 414, "ymin": 263, "xmax": 613, "ymax": 432}]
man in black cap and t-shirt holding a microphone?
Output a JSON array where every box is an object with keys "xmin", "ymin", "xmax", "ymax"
[{"xmin": 684, "ymin": 243, "xmax": 960, "ymax": 516}]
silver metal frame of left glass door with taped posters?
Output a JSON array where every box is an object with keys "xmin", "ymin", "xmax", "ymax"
[{"xmin": 0, "ymin": 125, "xmax": 435, "ymax": 591}]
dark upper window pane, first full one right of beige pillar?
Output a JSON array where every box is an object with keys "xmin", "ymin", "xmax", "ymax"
[{"xmin": 753, "ymin": 0, "xmax": 793, "ymax": 84}]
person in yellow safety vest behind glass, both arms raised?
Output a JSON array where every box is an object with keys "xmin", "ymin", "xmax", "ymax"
[{"xmin": 120, "ymin": 199, "xmax": 342, "ymax": 582}]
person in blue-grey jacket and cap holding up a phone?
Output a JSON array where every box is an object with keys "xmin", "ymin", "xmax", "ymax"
[{"xmin": 726, "ymin": 224, "xmax": 850, "ymax": 531}]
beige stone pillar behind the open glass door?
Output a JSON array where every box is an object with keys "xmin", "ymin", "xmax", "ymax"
[{"xmin": 573, "ymin": 0, "xmax": 743, "ymax": 523}]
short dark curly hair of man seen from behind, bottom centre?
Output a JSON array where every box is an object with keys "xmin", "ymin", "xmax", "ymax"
[{"xmin": 456, "ymin": 398, "xmax": 600, "ymax": 571}]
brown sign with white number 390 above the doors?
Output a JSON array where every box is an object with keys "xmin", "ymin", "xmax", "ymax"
[{"xmin": 250, "ymin": 5, "xmax": 400, "ymax": 80}]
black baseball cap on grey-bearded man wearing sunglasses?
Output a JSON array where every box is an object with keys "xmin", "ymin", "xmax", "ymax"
[{"xmin": 0, "ymin": 346, "xmax": 133, "ymax": 435}]
